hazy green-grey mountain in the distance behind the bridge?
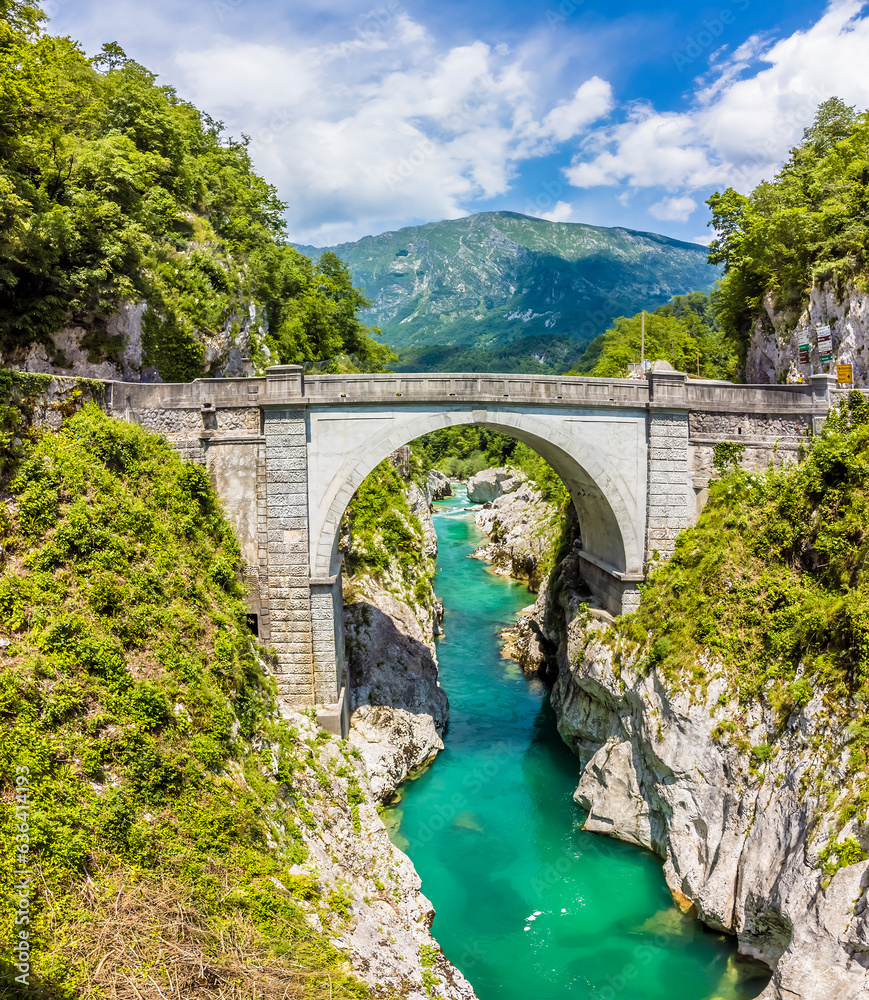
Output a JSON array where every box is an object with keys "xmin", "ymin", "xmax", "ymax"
[{"xmin": 296, "ymin": 212, "xmax": 720, "ymax": 367}]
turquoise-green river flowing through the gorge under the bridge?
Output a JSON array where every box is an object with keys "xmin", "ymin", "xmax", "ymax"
[{"xmin": 386, "ymin": 492, "xmax": 769, "ymax": 1000}]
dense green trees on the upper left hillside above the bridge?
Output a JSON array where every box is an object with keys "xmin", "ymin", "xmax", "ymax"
[{"xmin": 0, "ymin": 0, "xmax": 392, "ymax": 381}]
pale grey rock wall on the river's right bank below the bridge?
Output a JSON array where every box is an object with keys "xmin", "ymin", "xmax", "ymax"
[{"xmin": 517, "ymin": 528, "xmax": 869, "ymax": 1000}]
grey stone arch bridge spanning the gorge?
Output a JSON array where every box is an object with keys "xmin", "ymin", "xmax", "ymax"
[{"xmin": 107, "ymin": 362, "xmax": 836, "ymax": 731}]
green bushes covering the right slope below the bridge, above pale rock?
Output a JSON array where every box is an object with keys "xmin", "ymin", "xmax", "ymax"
[{"xmin": 618, "ymin": 391, "xmax": 869, "ymax": 828}]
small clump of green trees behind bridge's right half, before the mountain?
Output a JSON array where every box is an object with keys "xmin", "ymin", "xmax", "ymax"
[{"xmin": 570, "ymin": 292, "xmax": 737, "ymax": 379}]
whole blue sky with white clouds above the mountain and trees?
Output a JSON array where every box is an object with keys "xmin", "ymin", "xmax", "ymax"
[{"xmin": 45, "ymin": 0, "xmax": 869, "ymax": 246}]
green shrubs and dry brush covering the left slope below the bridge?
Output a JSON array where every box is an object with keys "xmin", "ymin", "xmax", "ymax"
[{"xmin": 0, "ymin": 394, "xmax": 368, "ymax": 1000}]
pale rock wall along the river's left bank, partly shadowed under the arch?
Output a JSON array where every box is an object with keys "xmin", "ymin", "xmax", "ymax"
[{"xmin": 336, "ymin": 458, "xmax": 475, "ymax": 1000}]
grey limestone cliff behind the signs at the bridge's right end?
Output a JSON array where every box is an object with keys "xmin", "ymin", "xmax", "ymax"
[{"xmin": 745, "ymin": 282, "xmax": 869, "ymax": 386}]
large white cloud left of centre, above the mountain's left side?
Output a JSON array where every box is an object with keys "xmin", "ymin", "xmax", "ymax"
[{"xmin": 177, "ymin": 15, "xmax": 612, "ymax": 245}]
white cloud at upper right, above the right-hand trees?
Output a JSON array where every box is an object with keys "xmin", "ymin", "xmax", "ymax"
[{"xmin": 565, "ymin": 0, "xmax": 869, "ymax": 197}]
